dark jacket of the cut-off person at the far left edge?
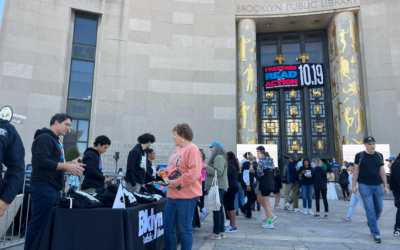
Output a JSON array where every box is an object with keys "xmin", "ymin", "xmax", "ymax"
[{"xmin": 0, "ymin": 119, "xmax": 25, "ymax": 204}]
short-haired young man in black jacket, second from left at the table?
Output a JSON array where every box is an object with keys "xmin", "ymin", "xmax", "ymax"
[{"xmin": 81, "ymin": 135, "xmax": 111, "ymax": 194}]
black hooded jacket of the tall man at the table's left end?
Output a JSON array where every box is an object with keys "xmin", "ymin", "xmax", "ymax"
[{"xmin": 31, "ymin": 128, "xmax": 65, "ymax": 190}]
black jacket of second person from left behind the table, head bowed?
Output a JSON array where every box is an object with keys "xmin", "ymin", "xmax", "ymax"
[{"xmin": 81, "ymin": 148, "xmax": 106, "ymax": 190}]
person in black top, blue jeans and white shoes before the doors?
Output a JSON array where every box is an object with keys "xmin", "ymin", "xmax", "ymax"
[{"xmin": 298, "ymin": 159, "xmax": 314, "ymax": 215}]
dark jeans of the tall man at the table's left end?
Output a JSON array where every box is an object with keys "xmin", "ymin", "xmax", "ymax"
[{"xmin": 24, "ymin": 184, "xmax": 61, "ymax": 250}]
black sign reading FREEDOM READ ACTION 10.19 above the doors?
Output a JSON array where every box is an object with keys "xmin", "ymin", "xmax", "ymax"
[{"xmin": 263, "ymin": 63, "xmax": 324, "ymax": 90}]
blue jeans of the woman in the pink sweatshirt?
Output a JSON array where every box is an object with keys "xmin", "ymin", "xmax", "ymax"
[{"xmin": 164, "ymin": 197, "xmax": 199, "ymax": 250}]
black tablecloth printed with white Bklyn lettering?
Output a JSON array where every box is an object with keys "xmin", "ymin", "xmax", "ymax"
[{"xmin": 31, "ymin": 198, "xmax": 200, "ymax": 250}]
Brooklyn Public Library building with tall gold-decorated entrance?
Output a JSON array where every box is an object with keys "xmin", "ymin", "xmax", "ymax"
[{"xmin": 0, "ymin": 0, "xmax": 400, "ymax": 172}]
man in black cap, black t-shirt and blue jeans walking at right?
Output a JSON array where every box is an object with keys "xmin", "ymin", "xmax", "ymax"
[{"xmin": 353, "ymin": 136, "xmax": 389, "ymax": 243}]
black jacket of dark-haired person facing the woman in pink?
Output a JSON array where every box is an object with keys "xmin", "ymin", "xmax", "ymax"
[{"xmin": 125, "ymin": 144, "xmax": 146, "ymax": 186}]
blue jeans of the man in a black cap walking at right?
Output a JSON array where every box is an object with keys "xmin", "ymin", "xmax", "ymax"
[{"xmin": 358, "ymin": 183, "xmax": 383, "ymax": 236}]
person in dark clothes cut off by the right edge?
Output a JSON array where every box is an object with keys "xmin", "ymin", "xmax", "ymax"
[{"xmin": 390, "ymin": 154, "xmax": 400, "ymax": 236}]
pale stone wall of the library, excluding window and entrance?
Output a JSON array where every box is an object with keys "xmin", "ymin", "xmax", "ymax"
[{"xmin": 0, "ymin": 0, "xmax": 400, "ymax": 171}]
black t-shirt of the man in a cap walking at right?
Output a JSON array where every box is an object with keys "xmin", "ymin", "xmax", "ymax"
[{"xmin": 354, "ymin": 152, "xmax": 384, "ymax": 186}]
